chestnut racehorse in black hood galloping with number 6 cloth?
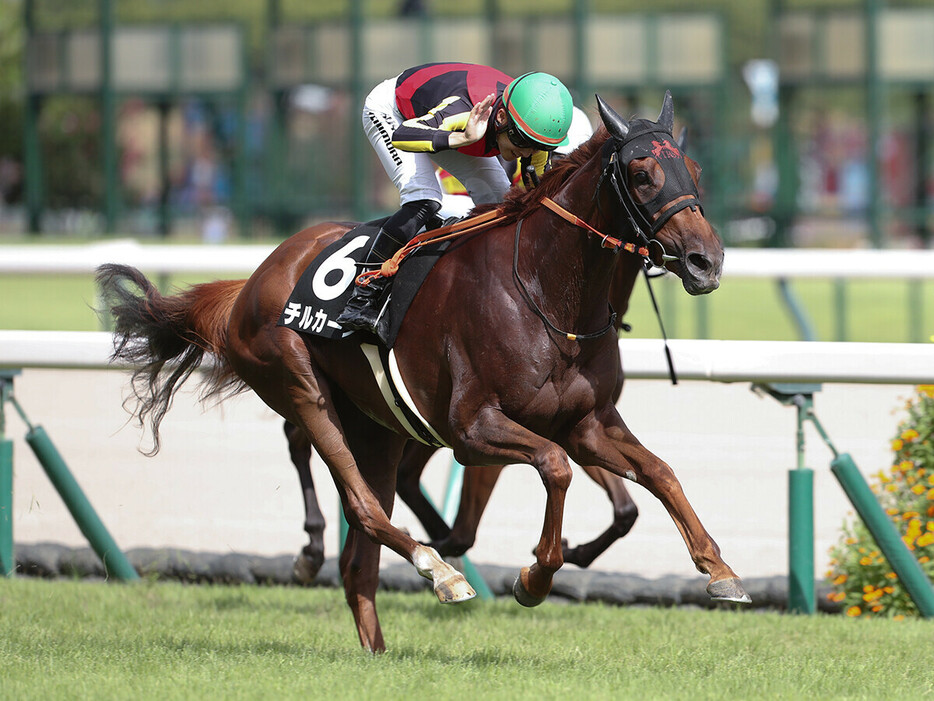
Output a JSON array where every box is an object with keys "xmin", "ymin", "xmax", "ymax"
[{"xmin": 98, "ymin": 94, "xmax": 749, "ymax": 652}]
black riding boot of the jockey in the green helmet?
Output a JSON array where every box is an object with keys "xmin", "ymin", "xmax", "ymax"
[{"xmin": 337, "ymin": 200, "xmax": 441, "ymax": 333}]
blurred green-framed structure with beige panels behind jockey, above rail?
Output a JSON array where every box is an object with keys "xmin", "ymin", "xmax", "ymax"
[{"xmin": 0, "ymin": 0, "xmax": 934, "ymax": 248}]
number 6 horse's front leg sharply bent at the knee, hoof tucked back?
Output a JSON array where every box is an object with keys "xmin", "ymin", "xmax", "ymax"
[{"xmin": 454, "ymin": 407, "xmax": 571, "ymax": 606}]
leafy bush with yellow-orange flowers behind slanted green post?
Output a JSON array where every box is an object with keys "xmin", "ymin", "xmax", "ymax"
[{"xmin": 827, "ymin": 385, "xmax": 934, "ymax": 618}]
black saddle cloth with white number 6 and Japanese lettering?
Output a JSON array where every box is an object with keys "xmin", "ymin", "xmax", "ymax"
[{"xmin": 277, "ymin": 218, "xmax": 449, "ymax": 348}]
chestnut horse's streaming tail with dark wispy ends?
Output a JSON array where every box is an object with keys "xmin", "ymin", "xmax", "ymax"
[{"xmin": 97, "ymin": 264, "xmax": 246, "ymax": 455}]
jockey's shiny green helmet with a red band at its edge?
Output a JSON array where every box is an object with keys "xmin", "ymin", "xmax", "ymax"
[{"xmin": 503, "ymin": 71, "xmax": 574, "ymax": 151}]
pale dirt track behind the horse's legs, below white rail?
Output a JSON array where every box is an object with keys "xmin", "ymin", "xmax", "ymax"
[{"xmin": 7, "ymin": 371, "xmax": 911, "ymax": 577}]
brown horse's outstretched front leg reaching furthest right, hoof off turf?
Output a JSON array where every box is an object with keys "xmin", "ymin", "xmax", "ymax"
[{"xmin": 570, "ymin": 407, "xmax": 751, "ymax": 603}]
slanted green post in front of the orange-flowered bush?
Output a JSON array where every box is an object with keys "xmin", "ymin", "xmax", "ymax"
[{"xmin": 830, "ymin": 453, "xmax": 934, "ymax": 618}]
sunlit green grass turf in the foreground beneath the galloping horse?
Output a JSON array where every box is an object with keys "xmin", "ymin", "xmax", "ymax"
[{"xmin": 0, "ymin": 578, "xmax": 934, "ymax": 701}]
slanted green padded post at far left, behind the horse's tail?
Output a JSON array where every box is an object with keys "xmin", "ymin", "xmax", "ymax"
[{"xmin": 26, "ymin": 426, "xmax": 139, "ymax": 581}]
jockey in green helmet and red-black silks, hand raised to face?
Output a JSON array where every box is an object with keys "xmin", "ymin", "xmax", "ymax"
[{"xmin": 337, "ymin": 63, "xmax": 572, "ymax": 331}]
